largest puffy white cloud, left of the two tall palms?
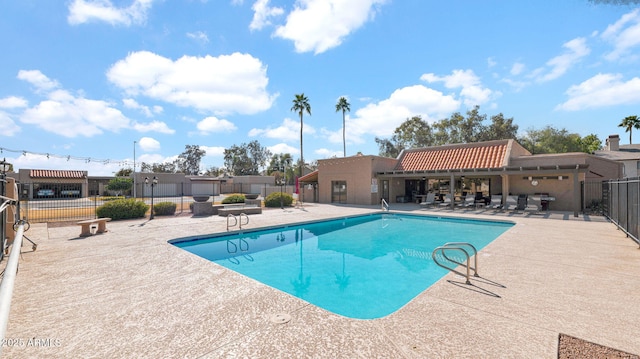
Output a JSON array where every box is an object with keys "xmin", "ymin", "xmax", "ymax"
[{"xmin": 107, "ymin": 51, "xmax": 277, "ymax": 115}]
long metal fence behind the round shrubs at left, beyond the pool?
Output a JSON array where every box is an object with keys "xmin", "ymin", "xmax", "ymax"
[{"xmin": 19, "ymin": 182, "xmax": 294, "ymax": 223}]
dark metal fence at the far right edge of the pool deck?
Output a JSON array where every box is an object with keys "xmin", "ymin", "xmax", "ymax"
[{"xmin": 602, "ymin": 177, "xmax": 640, "ymax": 248}]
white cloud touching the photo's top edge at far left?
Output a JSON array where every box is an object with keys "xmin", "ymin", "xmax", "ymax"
[{"xmin": 67, "ymin": 0, "xmax": 153, "ymax": 26}]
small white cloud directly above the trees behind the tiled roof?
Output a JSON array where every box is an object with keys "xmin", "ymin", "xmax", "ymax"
[{"xmin": 420, "ymin": 70, "xmax": 492, "ymax": 107}]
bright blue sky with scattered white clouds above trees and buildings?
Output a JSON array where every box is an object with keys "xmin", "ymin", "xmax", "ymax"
[{"xmin": 0, "ymin": 0, "xmax": 640, "ymax": 175}]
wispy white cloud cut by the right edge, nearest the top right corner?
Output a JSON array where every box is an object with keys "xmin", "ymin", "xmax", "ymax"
[{"xmin": 601, "ymin": 9, "xmax": 640, "ymax": 61}]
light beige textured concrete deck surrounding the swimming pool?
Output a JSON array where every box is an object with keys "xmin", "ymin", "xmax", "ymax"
[{"xmin": 2, "ymin": 204, "xmax": 640, "ymax": 358}]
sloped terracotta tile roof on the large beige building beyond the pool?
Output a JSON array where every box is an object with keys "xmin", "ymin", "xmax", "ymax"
[{"xmin": 395, "ymin": 140, "xmax": 511, "ymax": 171}]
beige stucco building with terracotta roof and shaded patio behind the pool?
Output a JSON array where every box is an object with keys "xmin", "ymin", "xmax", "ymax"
[{"xmin": 300, "ymin": 140, "xmax": 622, "ymax": 214}]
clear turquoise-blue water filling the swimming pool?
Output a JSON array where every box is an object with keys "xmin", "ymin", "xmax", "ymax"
[{"xmin": 172, "ymin": 214, "xmax": 513, "ymax": 319}]
